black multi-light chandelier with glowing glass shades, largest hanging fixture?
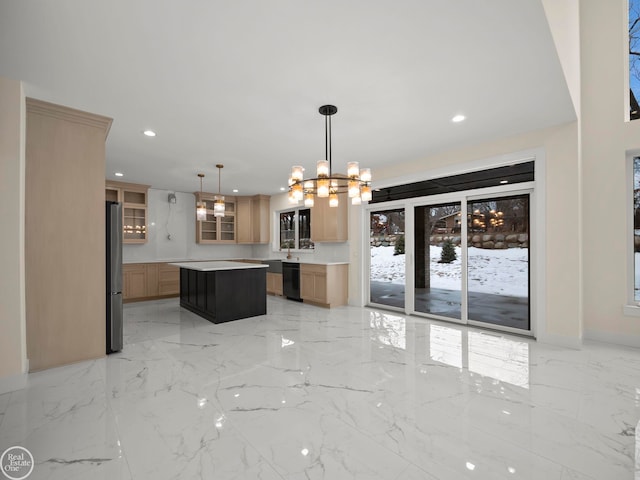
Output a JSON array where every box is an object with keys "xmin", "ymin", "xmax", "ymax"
[{"xmin": 289, "ymin": 105, "xmax": 371, "ymax": 207}]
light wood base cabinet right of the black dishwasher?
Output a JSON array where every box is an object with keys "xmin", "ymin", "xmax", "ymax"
[{"xmin": 300, "ymin": 263, "xmax": 349, "ymax": 307}]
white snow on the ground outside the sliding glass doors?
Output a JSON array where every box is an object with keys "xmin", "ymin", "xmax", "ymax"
[{"xmin": 371, "ymin": 245, "xmax": 528, "ymax": 297}]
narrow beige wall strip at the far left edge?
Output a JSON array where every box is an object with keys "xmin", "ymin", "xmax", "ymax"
[{"xmin": 0, "ymin": 77, "xmax": 26, "ymax": 394}]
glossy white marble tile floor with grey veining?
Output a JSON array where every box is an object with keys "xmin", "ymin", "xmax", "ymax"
[{"xmin": 0, "ymin": 296, "xmax": 640, "ymax": 480}]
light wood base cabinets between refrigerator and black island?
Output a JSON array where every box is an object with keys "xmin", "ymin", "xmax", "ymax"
[{"xmin": 122, "ymin": 263, "xmax": 180, "ymax": 302}]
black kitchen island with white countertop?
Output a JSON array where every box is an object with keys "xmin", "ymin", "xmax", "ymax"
[{"xmin": 171, "ymin": 261, "xmax": 267, "ymax": 323}]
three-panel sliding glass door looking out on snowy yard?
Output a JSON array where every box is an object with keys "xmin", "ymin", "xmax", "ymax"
[{"xmin": 369, "ymin": 189, "xmax": 531, "ymax": 332}]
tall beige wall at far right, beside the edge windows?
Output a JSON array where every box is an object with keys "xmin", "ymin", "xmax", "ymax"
[{"xmin": 580, "ymin": 0, "xmax": 640, "ymax": 346}]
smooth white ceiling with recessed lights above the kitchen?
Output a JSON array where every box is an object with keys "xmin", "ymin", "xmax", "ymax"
[{"xmin": 0, "ymin": 0, "xmax": 575, "ymax": 195}]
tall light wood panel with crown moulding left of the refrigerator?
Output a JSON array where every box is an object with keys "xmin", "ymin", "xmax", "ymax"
[{"xmin": 26, "ymin": 97, "xmax": 111, "ymax": 372}]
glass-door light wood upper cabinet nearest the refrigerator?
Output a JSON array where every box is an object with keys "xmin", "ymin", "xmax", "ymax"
[{"xmin": 105, "ymin": 180, "xmax": 149, "ymax": 243}]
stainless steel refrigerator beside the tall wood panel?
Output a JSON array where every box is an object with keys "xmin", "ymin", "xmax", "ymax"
[{"xmin": 106, "ymin": 202, "xmax": 123, "ymax": 353}]
